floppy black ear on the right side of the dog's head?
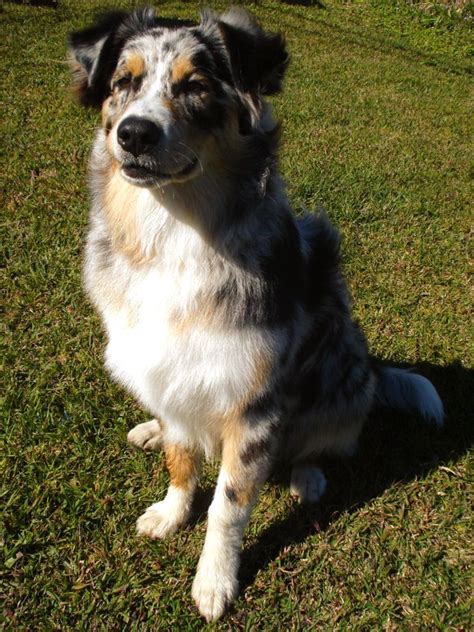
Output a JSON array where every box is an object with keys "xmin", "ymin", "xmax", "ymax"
[{"xmin": 219, "ymin": 8, "xmax": 289, "ymax": 96}]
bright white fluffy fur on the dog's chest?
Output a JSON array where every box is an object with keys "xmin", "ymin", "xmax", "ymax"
[{"xmin": 86, "ymin": 223, "xmax": 269, "ymax": 455}]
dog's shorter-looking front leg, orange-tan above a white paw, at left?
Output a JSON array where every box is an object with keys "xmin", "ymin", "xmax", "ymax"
[{"xmin": 137, "ymin": 444, "xmax": 201, "ymax": 539}]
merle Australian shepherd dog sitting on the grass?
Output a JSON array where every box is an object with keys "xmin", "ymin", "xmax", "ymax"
[{"xmin": 69, "ymin": 9, "xmax": 443, "ymax": 621}]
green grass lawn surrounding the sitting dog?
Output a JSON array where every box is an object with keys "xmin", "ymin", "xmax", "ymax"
[{"xmin": 0, "ymin": 0, "xmax": 474, "ymax": 630}]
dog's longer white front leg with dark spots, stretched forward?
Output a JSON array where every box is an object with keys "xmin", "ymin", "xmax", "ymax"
[{"xmin": 192, "ymin": 424, "xmax": 276, "ymax": 621}]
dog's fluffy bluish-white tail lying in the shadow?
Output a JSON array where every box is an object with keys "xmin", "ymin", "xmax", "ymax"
[{"xmin": 375, "ymin": 367, "xmax": 444, "ymax": 427}]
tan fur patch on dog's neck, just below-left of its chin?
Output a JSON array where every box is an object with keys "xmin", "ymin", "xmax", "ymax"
[{"xmin": 104, "ymin": 163, "xmax": 154, "ymax": 265}]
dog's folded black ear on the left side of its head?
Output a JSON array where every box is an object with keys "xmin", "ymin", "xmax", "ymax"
[{"xmin": 68, "ymin": 9, "xmax": 156, "ymax": 108}]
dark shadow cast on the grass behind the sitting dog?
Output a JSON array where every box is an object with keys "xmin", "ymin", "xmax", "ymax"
[{"xmin": 240, "ymin": 363, "xmax": 474, "ymax": 590}]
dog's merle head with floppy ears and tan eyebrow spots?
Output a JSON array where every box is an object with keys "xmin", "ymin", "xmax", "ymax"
[{"xmin": 69, "ymin": 9, "xmax": 288, "ymax": 186}]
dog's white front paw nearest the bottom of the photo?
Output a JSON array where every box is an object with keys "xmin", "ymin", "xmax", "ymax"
[{"xmin": 192, "ymin": 562, "xmax": 239, "ymax": 623}]
